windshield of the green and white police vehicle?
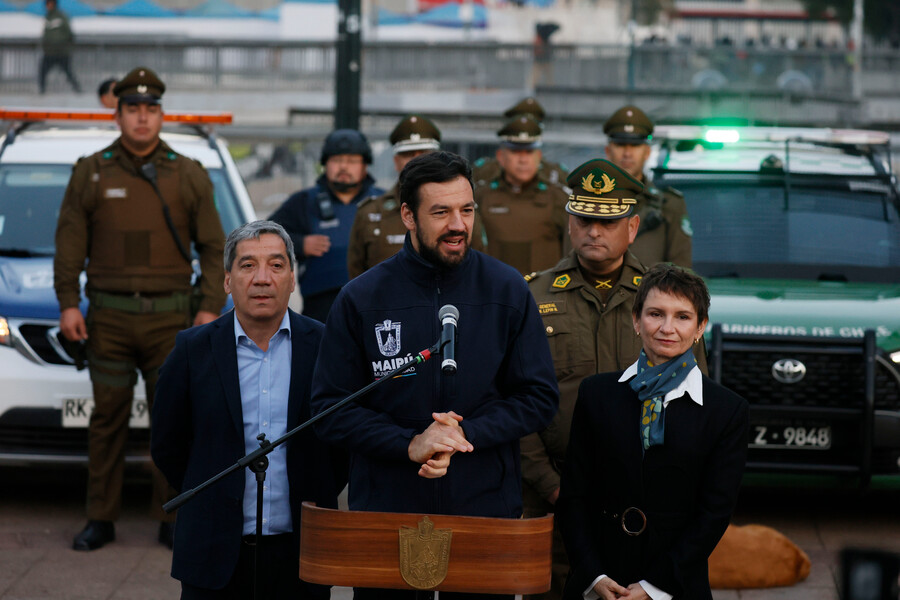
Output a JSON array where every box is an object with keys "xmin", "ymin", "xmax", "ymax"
[{"xmin": 678, "ymin": 180, "xmax": 900, "ymax": 281}]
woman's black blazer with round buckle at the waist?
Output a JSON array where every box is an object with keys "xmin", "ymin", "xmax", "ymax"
[{"xmin": 557, "ymin": 371, "xmax": 748, "ymax": 600}]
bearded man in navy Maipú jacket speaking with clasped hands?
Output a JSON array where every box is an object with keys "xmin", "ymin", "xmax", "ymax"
[{"xmin": 312, "ymin": 152, "xmax": 558, "ymax": 600}]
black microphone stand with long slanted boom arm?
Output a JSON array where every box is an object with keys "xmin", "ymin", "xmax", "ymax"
[{"xmin": 163, "ymin": 340, "xmax": 443, "ymax": 600}]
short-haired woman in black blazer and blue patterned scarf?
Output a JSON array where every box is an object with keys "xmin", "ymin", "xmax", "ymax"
[{"xmin": 557, "ymin": 264, "xmax": 748, "ymax": 600}]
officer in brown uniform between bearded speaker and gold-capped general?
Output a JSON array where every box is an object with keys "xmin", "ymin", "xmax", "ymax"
[{"xmin": 475, "ymin": 115, "xmax": 568, "ymax": 274}]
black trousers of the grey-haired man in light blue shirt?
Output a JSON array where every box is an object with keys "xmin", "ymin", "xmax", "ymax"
[{"xmin": 181, "ymin": 533, "xmax": 331, "ymax": 600}]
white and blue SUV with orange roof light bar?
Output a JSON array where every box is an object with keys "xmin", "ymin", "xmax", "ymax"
[{"xmin": 0, "ymin": 108, "xmax": 256, "ymax": 465}]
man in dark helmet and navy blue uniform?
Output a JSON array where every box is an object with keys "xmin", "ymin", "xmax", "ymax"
[{"xmin": 269, "ymin": 129, "xmax": 384, "ymax": 323}]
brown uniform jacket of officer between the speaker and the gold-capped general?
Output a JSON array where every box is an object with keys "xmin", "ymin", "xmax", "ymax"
[{"xmin": 475, "ymin": 169, "xmax": 569, "ymax": 274}]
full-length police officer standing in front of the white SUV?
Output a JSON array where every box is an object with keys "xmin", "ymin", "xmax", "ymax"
[{"xmin": 53, "ymin": 67, "xmax": 225, "ymax": 550}]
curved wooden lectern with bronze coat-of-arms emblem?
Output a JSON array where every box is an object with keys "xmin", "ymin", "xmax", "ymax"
[{"xmin": 300, "ymin": 502, "xmax": 553, "ymax": 594}]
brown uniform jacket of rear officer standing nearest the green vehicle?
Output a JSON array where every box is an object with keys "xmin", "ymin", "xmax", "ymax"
[{"xmin": 629, "ymin": 183, "xmax": 693, "ymax": 267}]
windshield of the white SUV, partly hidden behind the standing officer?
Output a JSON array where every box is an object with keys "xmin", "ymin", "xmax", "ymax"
[{"xmin": 0, "ymin": 164, "xmax": 244, "ymax": 256}]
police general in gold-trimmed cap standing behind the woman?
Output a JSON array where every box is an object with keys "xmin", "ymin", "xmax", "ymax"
[{"xmin": 521, "ymin": 159, "xmax": 645, "ymax": 598}]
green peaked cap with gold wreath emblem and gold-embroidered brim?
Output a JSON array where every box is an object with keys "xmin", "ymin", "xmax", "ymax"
[{"xmin": 566, "ymin": 158, "xmax": 644, "ymax": 219}]
